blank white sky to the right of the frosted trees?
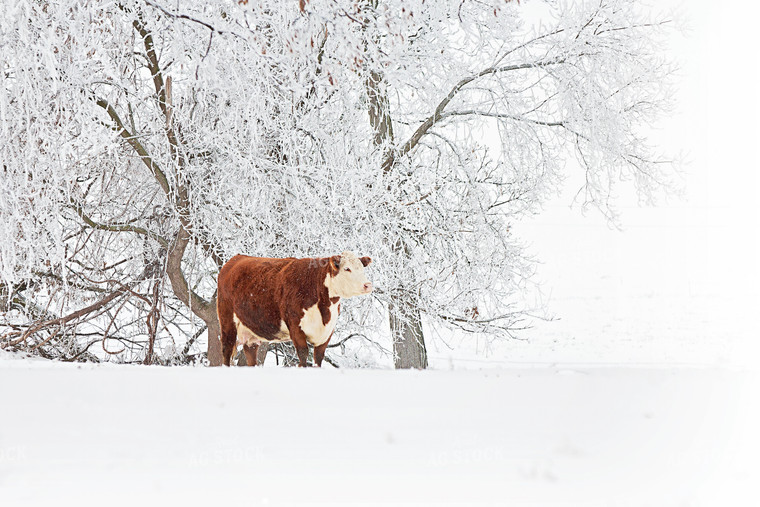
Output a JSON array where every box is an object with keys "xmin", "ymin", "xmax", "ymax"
[{"xmin": 484, "ymin": 0, "xmax": 760, "ymax": 364}]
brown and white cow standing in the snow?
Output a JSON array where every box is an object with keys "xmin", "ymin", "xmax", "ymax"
[{"xmin": 216, "ymin": 252, "xmax": 372, "ymax": 366}]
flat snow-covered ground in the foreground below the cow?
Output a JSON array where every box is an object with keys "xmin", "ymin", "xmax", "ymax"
[{"xmin": 0, "ymin": 354, "xmax": 760, "ymax": 506}]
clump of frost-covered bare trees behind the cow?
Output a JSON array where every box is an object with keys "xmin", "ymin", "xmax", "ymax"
[{"xmin": 0, "ymin": 0, "xmax": 670, "ymax": 367}]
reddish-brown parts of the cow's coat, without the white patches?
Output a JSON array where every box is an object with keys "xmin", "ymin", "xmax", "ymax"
[{"xmin": 217, "ymin": 255, "xmax": 344, "ymax": 366}]
